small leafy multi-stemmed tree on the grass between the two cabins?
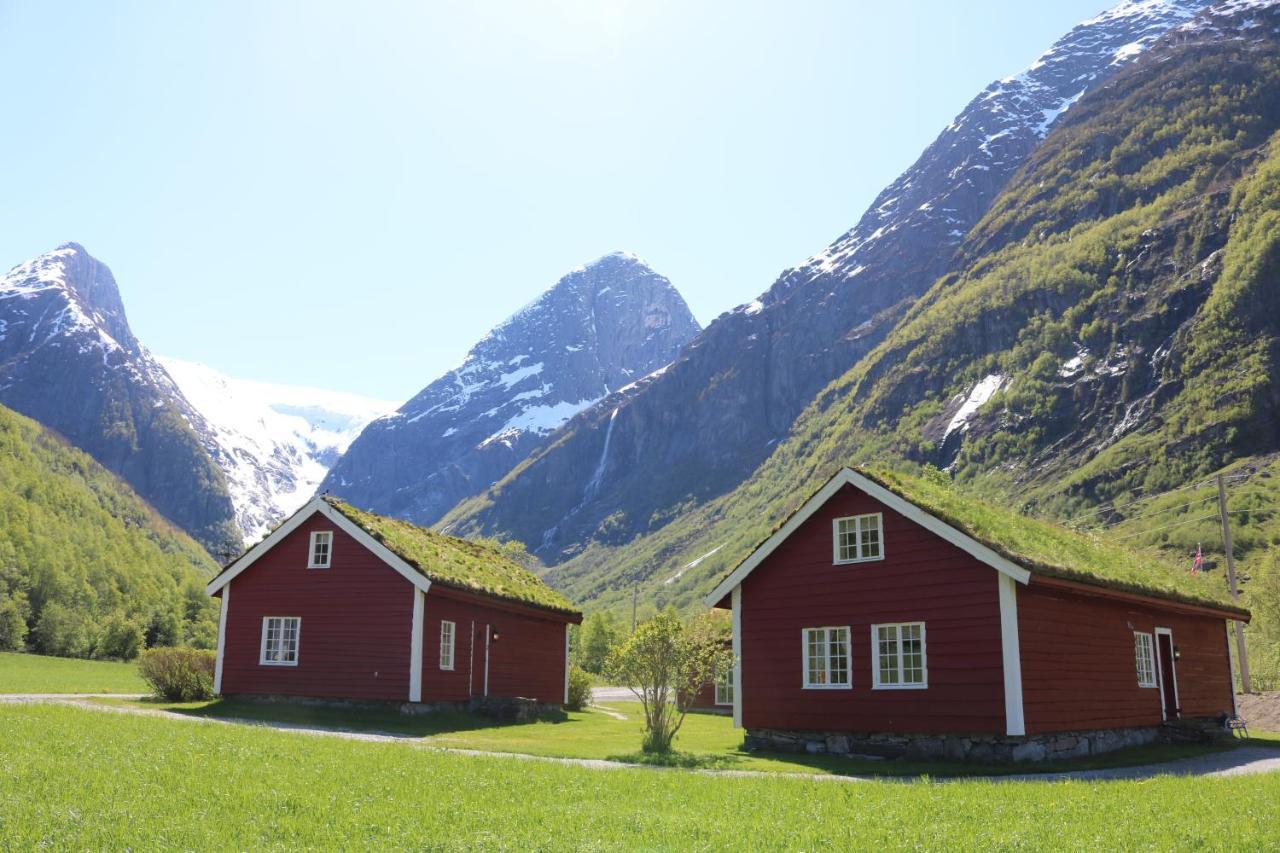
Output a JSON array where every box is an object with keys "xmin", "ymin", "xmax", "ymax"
[{"xmin": 605, "ymin": 611, "xmax": 733, "ymax": 753}]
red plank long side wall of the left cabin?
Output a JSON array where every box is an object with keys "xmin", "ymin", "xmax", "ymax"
[{"xmin": 422, "ymin": 584, "xmax": 567, "ymax": 704}]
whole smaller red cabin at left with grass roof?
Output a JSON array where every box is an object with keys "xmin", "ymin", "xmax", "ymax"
[{"xmin": 207, "ymin": 498, "xmax": 581, "ymax": 704}]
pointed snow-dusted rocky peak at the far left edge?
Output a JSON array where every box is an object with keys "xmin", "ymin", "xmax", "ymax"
[{"xmin": 0, "ymin": 243, "xmax": 239, "ymax": 553}]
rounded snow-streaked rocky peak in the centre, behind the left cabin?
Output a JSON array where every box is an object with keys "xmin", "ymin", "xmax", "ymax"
[{"xmin": 321, "ymin": 252, "xmax": 699, "ymax": 524}]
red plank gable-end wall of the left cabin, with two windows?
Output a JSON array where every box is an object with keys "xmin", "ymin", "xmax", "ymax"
[{"xmin": 223, "ymin": 514, "xmax": 413, "ymax": 701}]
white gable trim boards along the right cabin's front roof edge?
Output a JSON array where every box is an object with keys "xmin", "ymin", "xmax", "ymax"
[{"xmin": 703, "ymin": 467, "xmax": 1032, "ymax": 607}]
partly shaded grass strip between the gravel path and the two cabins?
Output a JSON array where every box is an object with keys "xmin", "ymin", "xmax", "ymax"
[{"xmin": 92, "ymin": 699, "xmax": 1280, "ymax": 776}]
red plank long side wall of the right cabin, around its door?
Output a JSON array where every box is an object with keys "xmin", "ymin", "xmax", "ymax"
[{"xmin": 1018, "ymin": 578, "xmax": 1233, "ymax": 734}]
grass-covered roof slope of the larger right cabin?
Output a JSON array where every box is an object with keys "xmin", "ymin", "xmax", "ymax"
[{"xmin": 737, "ymin": 469, "xmax": 1248, "ymax": 615}]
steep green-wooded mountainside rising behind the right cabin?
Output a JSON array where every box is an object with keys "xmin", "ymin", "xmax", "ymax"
[{"xmin": 535, "ymin": 0, "xmax": 1280, "ymax": 678}]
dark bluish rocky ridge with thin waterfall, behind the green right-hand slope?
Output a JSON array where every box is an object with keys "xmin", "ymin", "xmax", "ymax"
[{"xmin": 445, "ymin": 0, "xmax": 1206, "ymax": 564}]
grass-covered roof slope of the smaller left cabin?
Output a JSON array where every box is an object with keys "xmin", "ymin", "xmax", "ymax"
[{"xmin": 325, "ymin": 497, "xmax": 579, "ymax": 613}]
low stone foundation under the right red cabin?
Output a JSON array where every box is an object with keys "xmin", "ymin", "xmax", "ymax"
[{"xmin": 744, "ymin": 720, "xmax": 1229, "ymax": 763}]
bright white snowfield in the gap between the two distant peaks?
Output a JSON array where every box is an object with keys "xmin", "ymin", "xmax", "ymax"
[{"xmin": 160, "ymin": 356, "xmax": 397, "ymax": 542}]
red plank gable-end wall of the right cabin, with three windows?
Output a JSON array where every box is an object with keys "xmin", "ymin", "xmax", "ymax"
[{"xmin": 741, "ymin": 487, "xmax": 1005, "ymax": 734}]
